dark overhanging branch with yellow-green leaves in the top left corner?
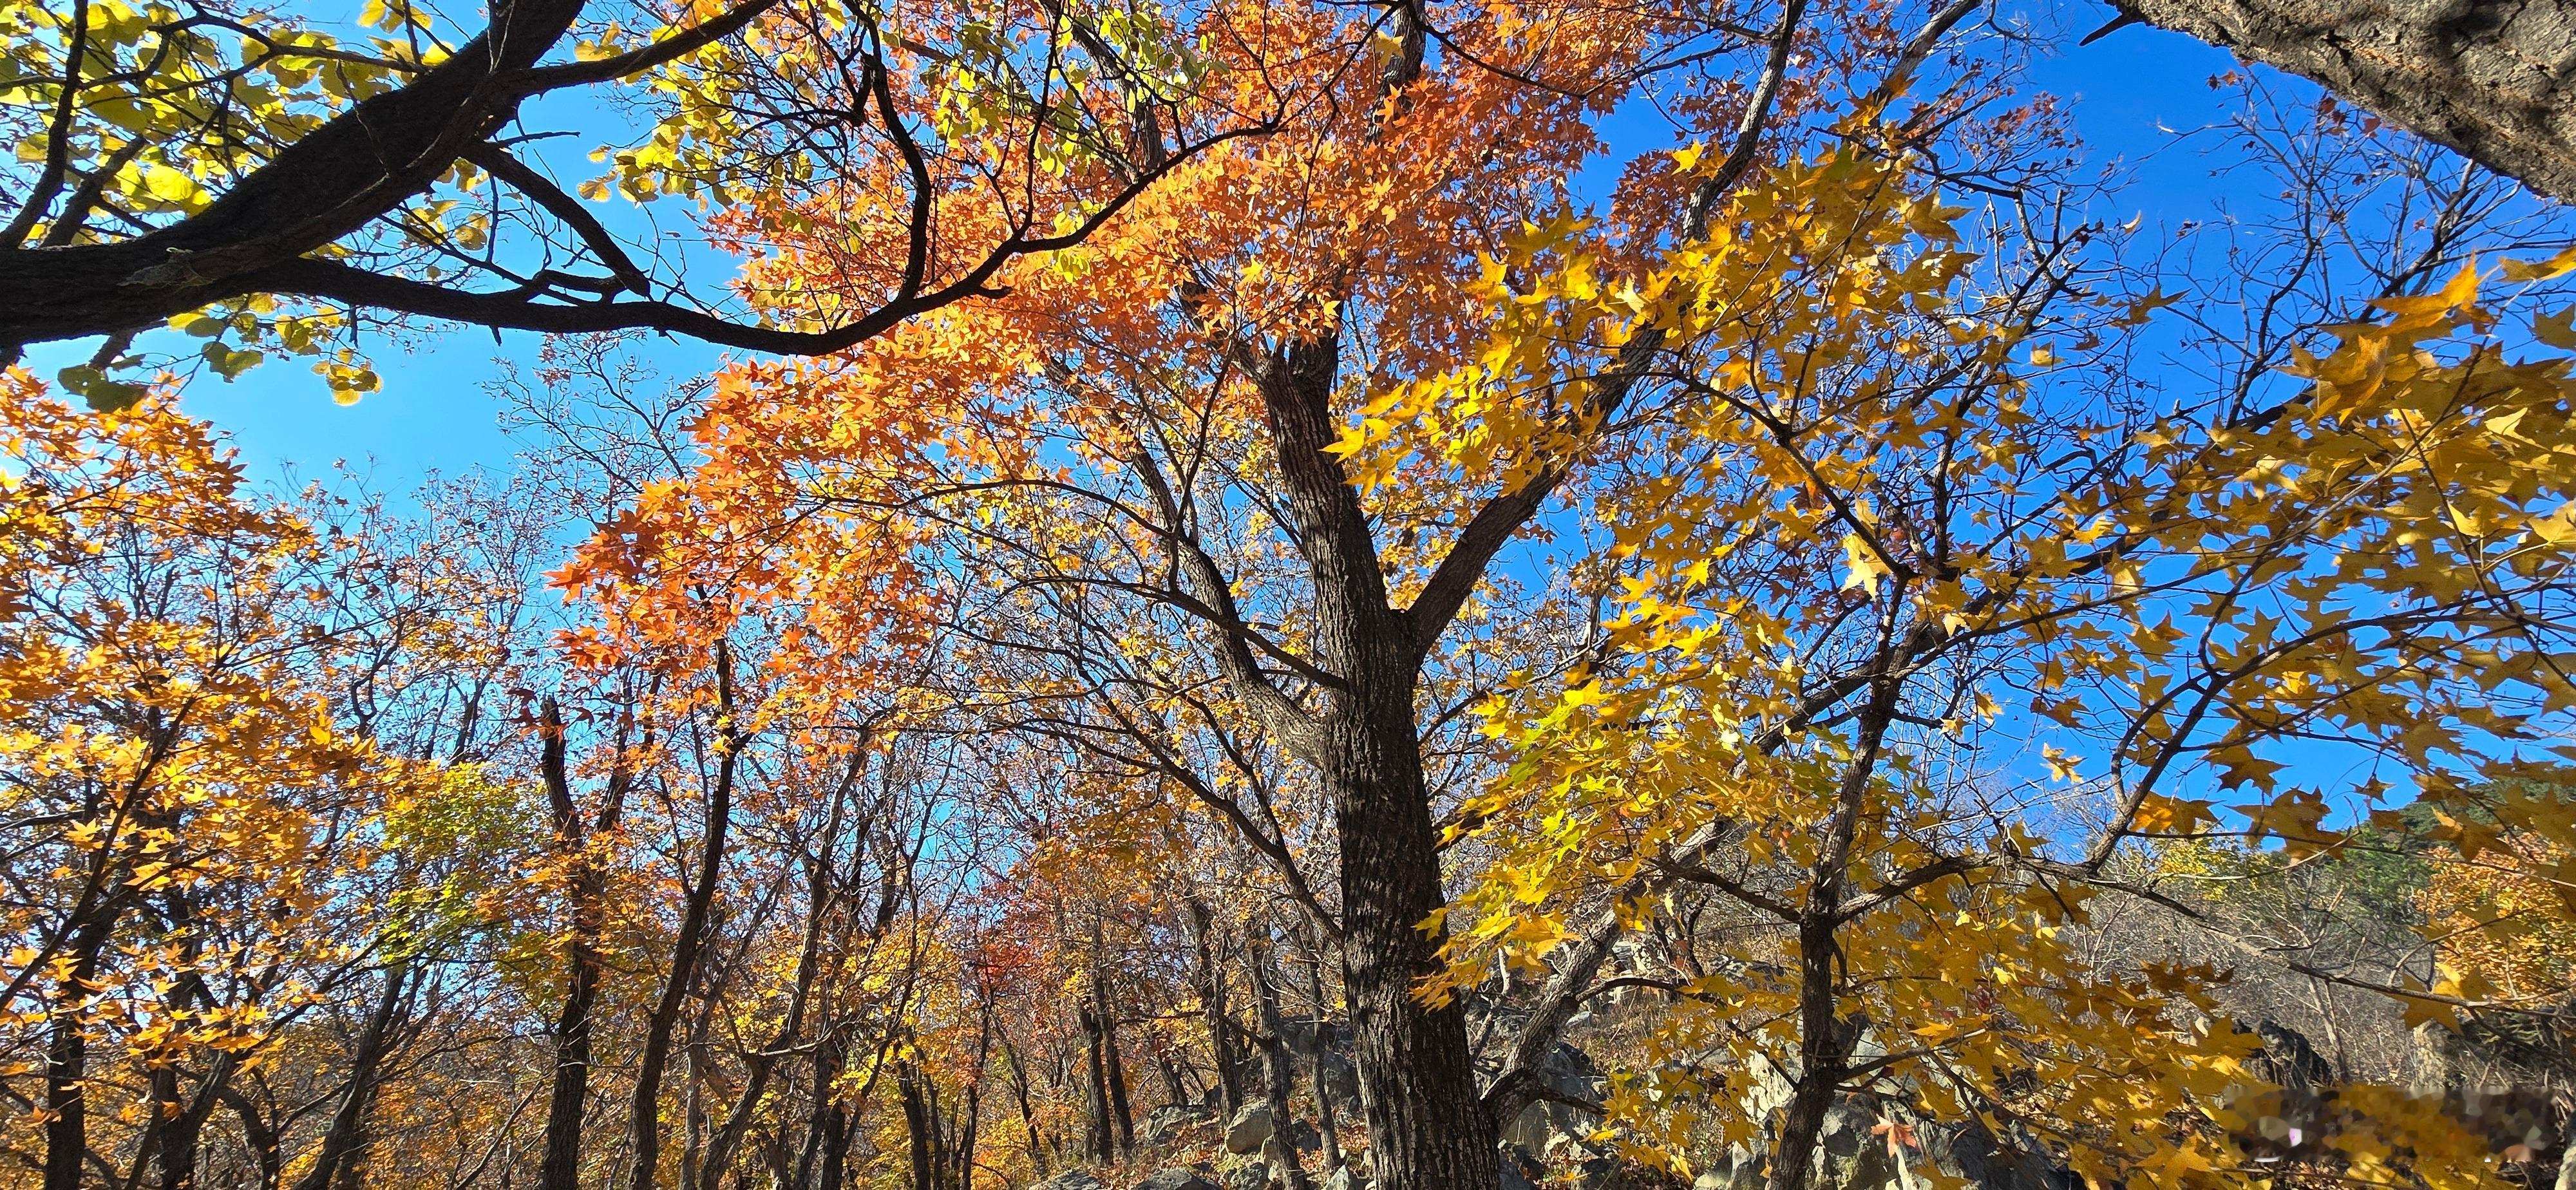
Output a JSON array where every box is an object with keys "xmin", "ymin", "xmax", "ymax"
[{"xmin": 0, "ymin": 0, "xmax": 1244, "ymax": 404}]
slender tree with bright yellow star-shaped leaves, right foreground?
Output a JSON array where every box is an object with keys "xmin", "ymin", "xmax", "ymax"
[{"xmin": 1422, "ymin": 135, "xmax": 2576, "ymax": 1190}]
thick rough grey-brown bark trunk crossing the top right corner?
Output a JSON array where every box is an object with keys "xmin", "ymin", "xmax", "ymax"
[{"xmin": 2115, "ymin": 0, "xmax": 2576, "ymax": 201}]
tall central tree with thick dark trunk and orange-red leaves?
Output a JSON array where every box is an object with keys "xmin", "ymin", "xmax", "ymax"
[{"xmin": 544, "ymin": 5, "xmax": 2030, "ymax": 1187}]
